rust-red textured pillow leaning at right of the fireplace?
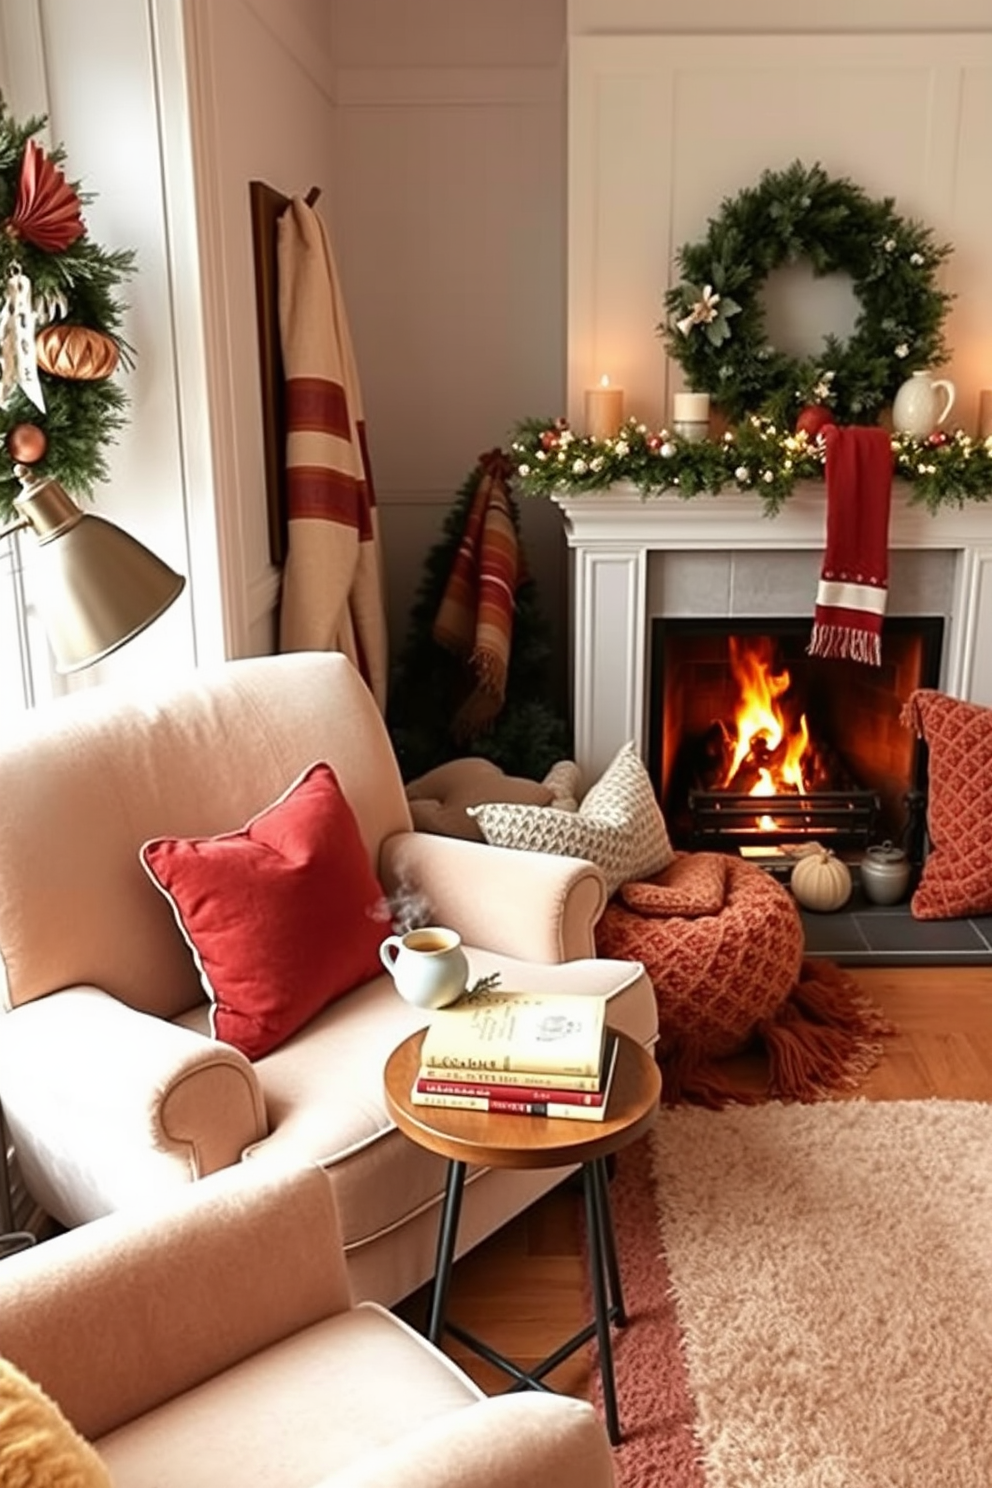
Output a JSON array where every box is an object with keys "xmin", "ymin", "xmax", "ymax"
[{"xmin": 903, "ymin": 687, "xmax": 992, "ymax": 920}]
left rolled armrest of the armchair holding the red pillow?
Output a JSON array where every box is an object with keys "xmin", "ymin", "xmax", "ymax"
[{"xmin": 0, "ymin": 987, "xmax": 268, "ymax": 1225}]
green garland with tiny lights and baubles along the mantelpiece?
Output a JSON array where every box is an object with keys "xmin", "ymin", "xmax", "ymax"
[{"xmin": 510, "ymin": 415, "xmax": 992, "ymax": 516}]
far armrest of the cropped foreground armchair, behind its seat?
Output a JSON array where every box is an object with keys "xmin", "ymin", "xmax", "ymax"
[{"xmin": 0, "ymin": 1162, "xmax": 350, "ymax": 1440}]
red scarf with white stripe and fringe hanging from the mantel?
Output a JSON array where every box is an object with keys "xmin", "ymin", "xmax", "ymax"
[{"xmin": 808, "ymin": 424, "xmax": 892, "ymax": 667}]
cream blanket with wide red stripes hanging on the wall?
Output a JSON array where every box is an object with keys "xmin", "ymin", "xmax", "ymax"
[{"xmin": 278, "ymin": 196, "xmax": 387, "ymax": 710}]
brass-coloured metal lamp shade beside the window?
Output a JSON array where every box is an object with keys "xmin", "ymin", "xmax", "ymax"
[{"xmin": 13, "ymin": 478, "xmax": 186, "ymax": 673}]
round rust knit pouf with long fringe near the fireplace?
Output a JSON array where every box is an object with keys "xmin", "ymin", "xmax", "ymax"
[{"xmin": 596, "ymin": 853, "xmax": 891, "ymax": 1104}]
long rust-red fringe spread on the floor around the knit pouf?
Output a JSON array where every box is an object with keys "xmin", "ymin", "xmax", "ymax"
[{"xmin": 659, "ymin": 958, "xmax": 895, "ymax": 1109}]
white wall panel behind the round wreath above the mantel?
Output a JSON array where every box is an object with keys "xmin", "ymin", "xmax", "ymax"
[{"xmin": 568, "ymin": 33, "xmax": 992, "ymax": 426}]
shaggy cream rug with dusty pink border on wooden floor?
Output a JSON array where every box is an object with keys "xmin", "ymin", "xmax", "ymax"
[{"xmin": 588, "ymin": 1100, "xmax": 992, "ymax": 1488}]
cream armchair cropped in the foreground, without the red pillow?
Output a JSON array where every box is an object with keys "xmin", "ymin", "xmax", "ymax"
[{"xmin": 0, "ymin": 1165, "xmax": 613, "ymax": 1488}]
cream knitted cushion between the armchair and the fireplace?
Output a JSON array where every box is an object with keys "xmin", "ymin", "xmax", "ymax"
[{"xmin": 468, "ymin": 743, "xmax": 674, "ymax": 894}]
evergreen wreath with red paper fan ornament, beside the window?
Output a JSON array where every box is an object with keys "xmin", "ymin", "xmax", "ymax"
[{"xmin": 0, "ymin": 95, "xmax": 134, "ymax": 519}]
